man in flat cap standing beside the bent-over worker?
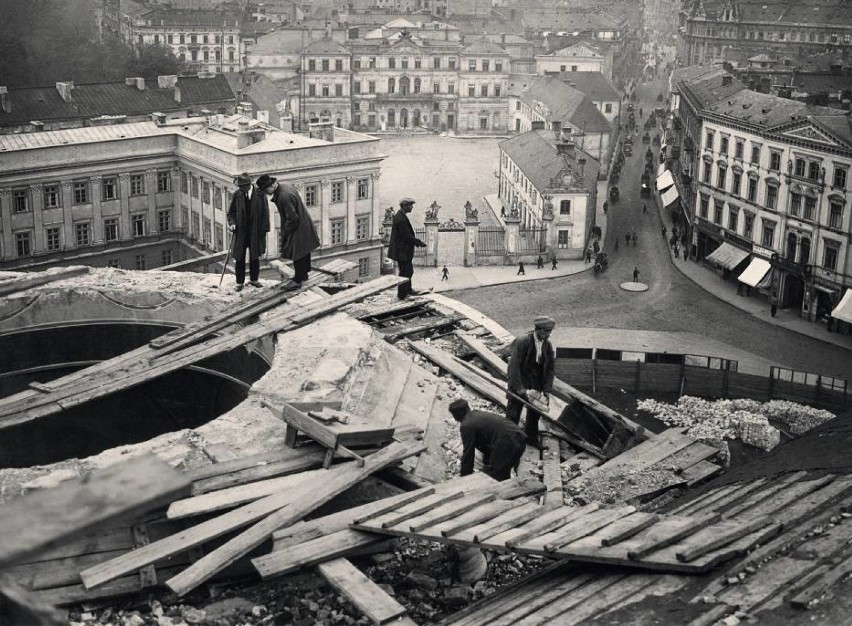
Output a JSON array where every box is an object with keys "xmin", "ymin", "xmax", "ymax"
[{"xmin": 506, "ymin": 316, "xmax": 556, "ymax": 448}]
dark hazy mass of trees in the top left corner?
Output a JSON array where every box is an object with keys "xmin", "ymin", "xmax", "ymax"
[{"xmin": 0, "ymin": 0, "xmax": 182, "ymax": 87}]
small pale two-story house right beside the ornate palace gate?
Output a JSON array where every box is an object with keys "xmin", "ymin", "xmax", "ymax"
[{"xmin": 499, "ymin": 127, "xmax": 600, "ymax": 259}]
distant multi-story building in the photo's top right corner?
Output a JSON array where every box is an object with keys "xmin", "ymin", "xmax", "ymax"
[{"xmin": 679, "ymin": 0, "xmax": 852, "ymax": 65}]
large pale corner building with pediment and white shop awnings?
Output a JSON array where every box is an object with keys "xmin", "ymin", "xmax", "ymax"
[{"xmin": 678, "ymin": 70, "xmax": 852, "ymax": 320}]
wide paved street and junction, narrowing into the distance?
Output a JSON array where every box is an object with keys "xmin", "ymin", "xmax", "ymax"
[{"xmin": 448, "ymin": 80, "xmax": 852, "ymax": 379}]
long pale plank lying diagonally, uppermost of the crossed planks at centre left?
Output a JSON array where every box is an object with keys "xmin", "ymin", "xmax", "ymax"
[{"xmin": 166, "ymin": 442, "xmax": 424, "ymax": 596}]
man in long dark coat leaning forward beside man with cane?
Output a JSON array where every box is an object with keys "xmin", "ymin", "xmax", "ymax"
[{"xmin": 257, "ymin": 174, "xmax": 320, "ymax": 291}]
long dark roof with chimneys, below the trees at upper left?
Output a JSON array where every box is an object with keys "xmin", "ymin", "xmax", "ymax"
[{"xmin": 0, "ymin": 75, "xmax": 234, "ymax": 126}]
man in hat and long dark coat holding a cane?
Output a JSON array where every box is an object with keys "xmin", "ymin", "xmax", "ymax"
[{"xmin": 228, "ymin": 173, "xmax": 269, "ymax": 291}]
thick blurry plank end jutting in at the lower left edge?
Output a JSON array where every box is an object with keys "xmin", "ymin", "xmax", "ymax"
[{"xmin": 0, "ymin": 454, "xmax": 190, "ymax": 568}]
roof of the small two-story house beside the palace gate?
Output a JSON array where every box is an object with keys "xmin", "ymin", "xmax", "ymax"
[{"xmin": 500, "ymin": 130, "xmax": 600, "ymax": 190}]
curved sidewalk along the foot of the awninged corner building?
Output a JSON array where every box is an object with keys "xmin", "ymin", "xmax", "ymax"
[{"xmin": 654, "ymin": 191, "xmax": 852, "ymax": 350}]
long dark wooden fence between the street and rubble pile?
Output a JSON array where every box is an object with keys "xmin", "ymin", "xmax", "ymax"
[{"xmin": 556, "ymin": 355, "xmax": 852, "ymax": 413}]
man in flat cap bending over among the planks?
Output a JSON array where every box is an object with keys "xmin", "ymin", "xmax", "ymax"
[{"xmin": 450, "ymin": 399, "xmax": 527, "ymax": 480}]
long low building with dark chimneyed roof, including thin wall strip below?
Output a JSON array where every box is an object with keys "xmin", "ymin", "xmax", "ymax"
[{"xmin": 0, "ymin": 75, "xmax": 234, "ymax": 134}]
